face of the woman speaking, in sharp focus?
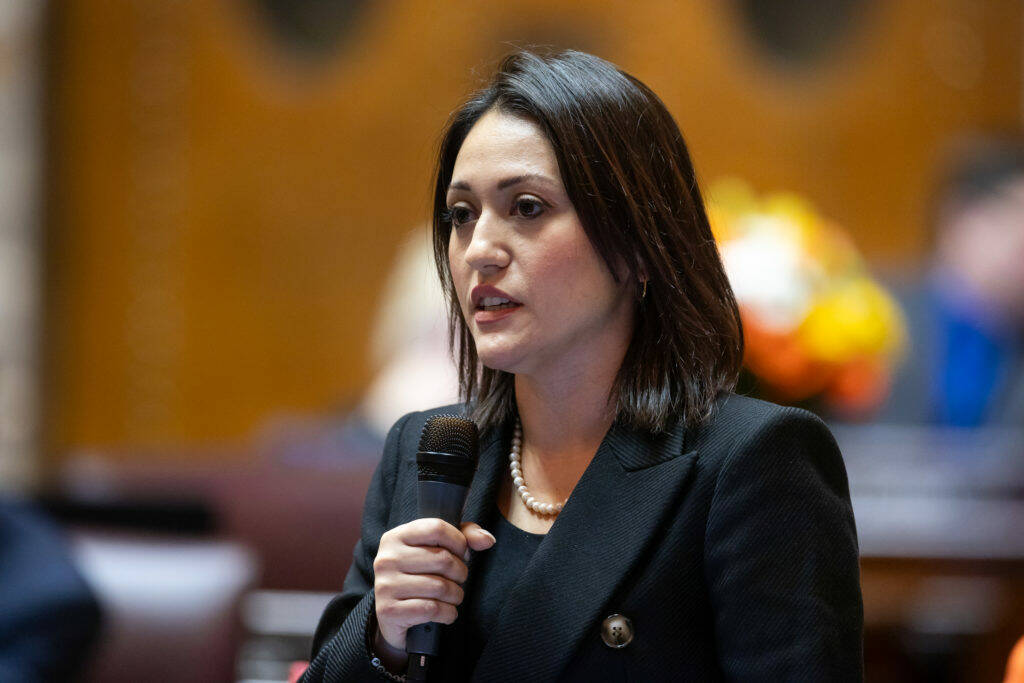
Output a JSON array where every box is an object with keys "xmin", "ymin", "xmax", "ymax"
[{"xmin": 447, "ymin": 110, "xmax": 634, "ymax": 376}]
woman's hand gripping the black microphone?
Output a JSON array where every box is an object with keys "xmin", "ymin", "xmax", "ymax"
[{"xmin": 374, "ymin": 518, "xmax": 495, "ymax": 651}]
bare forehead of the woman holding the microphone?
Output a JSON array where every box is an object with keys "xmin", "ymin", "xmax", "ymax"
[{"xmin": 452, "ymin": 110, "xmax": 560, "ymax": 182}]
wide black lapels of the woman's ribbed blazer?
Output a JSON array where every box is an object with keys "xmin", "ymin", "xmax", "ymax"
[{"xmin": 467, "ymin": 423, "xmax": 695, "ymax": 681}]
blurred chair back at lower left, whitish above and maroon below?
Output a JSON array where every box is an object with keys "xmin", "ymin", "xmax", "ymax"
[{"xmin": 74, "ymin": 531, "xmax": 257, "ymax": 683}]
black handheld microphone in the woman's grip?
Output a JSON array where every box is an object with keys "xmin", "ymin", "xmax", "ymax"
[{"xmin": 406, "ymin": 415, "xmax": 479, "ymax": 681}]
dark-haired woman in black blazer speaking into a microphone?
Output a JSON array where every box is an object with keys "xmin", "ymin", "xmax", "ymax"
[{"xmin": 305, "ymin": 51, "xmax": 862, "ymax": 681}]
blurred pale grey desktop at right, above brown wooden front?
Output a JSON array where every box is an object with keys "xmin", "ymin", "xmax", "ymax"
[{"xmin": 831, "ymin": 425, "xmax": 1024, "ymax": 562}]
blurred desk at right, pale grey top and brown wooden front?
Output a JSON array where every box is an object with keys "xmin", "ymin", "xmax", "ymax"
[{"xmin": 833, "ymin": 424, "xmax": 1024, "ymax": 683}]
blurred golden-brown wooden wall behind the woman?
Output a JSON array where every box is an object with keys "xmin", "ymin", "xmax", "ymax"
[{"xmin": 42, "ymin": 0, "xmax": 1022, "ymax": 464}]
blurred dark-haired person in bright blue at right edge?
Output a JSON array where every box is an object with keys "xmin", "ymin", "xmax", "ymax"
[{"xmin": 883, "ymin": 136, "xmax": 1024, "ymax": 427}]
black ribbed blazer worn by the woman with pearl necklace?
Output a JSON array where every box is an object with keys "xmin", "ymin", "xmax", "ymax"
[{"xmin": 303, "ymin": 394, "xmax": 863, "ymax": 682}]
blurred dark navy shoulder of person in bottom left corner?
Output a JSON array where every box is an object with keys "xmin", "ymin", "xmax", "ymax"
[{"xmin": 0, "ymin": 501, "xmax": 100, "ymax": 683}]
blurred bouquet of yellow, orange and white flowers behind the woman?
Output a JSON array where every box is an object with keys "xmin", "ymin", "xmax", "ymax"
[{"xmin": 708, "ymin": 179, "xmax": 906, "ymax": 419}]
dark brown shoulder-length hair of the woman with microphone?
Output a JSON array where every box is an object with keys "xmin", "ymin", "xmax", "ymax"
[{"xmin": 433, "ymin": 50, "xmax": 743, "ymax": 432}]
